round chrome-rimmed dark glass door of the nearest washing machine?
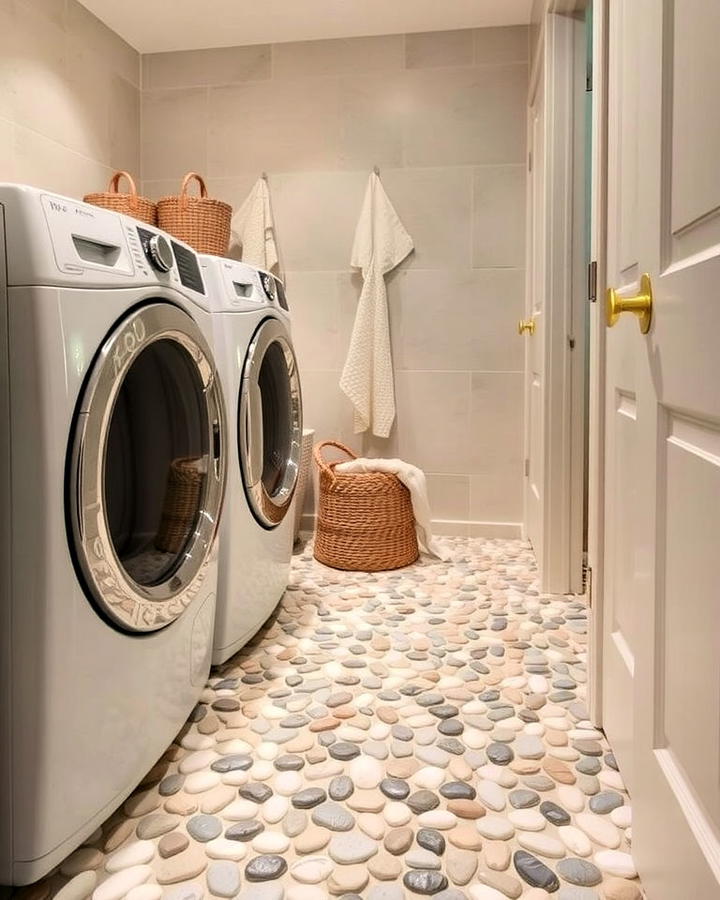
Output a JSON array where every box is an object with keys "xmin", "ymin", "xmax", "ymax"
[{"xmin": 68, "ymin": 303, "xmax": 225, "ymax": 632}]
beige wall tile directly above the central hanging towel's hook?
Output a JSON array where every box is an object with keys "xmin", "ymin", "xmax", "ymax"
[{"xmin": 339, "ymin": 73, "xmax": 407, "ymax": 170}]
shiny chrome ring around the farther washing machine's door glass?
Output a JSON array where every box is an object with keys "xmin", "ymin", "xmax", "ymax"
[{"xmin": 238, "ymin": 318, "xmax": 302, "ymax": 528}]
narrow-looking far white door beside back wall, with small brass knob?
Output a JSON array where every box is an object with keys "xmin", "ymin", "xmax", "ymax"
[{"xmin": 520, "ymin": 70, "xmax": 546, "ymax": 563}]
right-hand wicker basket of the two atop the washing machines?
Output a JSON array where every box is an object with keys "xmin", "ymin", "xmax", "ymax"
[{"xmin": 158, "ymin": 172, "xmax": 232, "ymax": 256}]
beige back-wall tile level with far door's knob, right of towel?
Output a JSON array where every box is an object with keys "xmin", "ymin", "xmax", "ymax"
[{"xmin": 388, "ymin": 268, "xmax": 525, "ymax": 371}]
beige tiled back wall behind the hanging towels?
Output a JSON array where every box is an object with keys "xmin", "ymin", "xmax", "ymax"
[{"xmin": 142, "ymin": 27, "xmax": 528, "ymax": 534}]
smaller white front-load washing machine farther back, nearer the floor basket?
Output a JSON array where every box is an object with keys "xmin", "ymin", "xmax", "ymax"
[{"xmin": 201, "ymin": 256, "xmax": 302, "ymax": 664}]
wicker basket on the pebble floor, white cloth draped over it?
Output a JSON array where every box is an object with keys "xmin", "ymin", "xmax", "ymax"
[{"xmin": 315, "ymin": 441, "xmax": 419, "ymax": 572}]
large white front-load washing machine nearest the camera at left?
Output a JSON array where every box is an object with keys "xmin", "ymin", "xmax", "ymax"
[{"xmin": 0, "ymin": 184, "xmax": 226, "ymax": 884}]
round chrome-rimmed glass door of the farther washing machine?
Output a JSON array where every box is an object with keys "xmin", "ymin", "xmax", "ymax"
[{"xmin": 238, "ymin": 319, "xmax": 302, "ymax": 528}]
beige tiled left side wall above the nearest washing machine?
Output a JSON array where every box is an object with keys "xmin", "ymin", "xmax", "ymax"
[{"xmin": 0, "ymin": 0, "xmax": 140, "ymax": 197}]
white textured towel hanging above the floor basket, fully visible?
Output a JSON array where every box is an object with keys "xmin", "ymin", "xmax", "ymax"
[{"xmin": 340, "ymin": 173, "xmax": 413, "ymax": 437}]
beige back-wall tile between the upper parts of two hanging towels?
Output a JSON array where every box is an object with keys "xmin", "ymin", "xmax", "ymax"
[{"xmin": 272, "ymin": 172, "xmax": 367, "ymax": 272}]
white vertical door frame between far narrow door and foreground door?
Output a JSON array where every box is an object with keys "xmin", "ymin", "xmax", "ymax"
[{"xmin": 525, "ymin": 7, "xmax": 587, "ymax": 594}]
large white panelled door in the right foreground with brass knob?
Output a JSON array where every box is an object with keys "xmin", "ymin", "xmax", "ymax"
[{"xmin": 603, "ymin": 0, "xmax": 720, "ymax": 900}]
